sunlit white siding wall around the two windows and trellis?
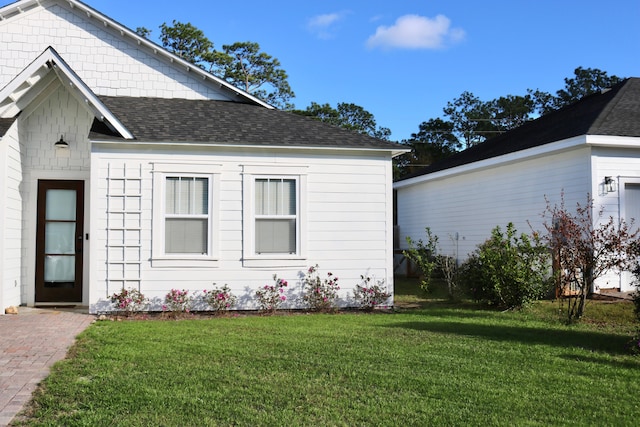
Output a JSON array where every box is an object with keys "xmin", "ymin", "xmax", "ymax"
[{"xmin": 90, "ymin": 149, "xmax": 393, "ymax": 312}]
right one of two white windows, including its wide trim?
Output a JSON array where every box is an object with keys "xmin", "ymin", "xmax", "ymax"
[{"xmin": 243, "ymin": 165, "xmax": 306, "ymax": 267}]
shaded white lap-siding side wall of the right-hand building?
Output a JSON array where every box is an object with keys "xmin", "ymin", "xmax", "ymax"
[{"xmin": 398, "ymin": 149, "xmax": 591, "ymax": 261}]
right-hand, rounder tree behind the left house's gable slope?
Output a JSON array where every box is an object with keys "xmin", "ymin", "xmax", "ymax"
[{"xmin": 212, "ymin": 42, "xmax": 295, "ymax": 109}]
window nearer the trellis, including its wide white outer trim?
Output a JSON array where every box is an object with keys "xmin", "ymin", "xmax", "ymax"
[{"xmin": 152, "ymin": 163, "xmax": 220, "ymax": 267}]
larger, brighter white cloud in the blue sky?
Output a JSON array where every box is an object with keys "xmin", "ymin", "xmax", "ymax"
[{"xmin": 367, "ymin": 15, "xmax": 465, "ymax": 49}]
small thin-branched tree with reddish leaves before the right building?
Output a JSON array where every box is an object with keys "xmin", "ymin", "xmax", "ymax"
[{"xmin": 542, "ymin": 193, "xmax": 639, "ymax": 322}]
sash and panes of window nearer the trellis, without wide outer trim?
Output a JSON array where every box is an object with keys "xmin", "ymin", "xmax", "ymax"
[{"xmin": 164, "ymin": 176, "xmax": 210, "ymax": 255}]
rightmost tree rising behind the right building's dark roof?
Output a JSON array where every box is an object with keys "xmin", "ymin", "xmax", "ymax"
[{"xmin": 528, "ymin": 67, "xmax": 624, "ymax": 114}]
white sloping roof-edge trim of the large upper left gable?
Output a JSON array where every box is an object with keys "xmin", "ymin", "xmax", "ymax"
[{"xmin": 0, "ymin": 0, "xmax": 275, "ymax": 108}]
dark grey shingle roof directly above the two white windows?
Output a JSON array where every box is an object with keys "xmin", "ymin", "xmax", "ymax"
[{"xmin": 90, "ymin": 96, "xmax": 405, "ymax": 150}]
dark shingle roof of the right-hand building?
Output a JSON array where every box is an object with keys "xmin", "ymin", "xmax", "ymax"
[{"xmin": 400, "ymin": 78, "xmax": 640, "ymax": 181}]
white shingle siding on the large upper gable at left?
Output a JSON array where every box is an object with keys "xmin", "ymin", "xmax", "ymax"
[{"xmin": 0, "ymin": 2, "xmax": 228, "ymax": 99}]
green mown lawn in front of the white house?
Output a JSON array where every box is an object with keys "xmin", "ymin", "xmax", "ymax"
[{"xmin": 13, "ymin": 281, "xmax": 640, "ymax": 426}]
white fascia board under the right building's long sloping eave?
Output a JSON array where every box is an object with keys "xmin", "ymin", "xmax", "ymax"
[{"xmin": 393, "ymin": 135, "xmax": 586, "ymax": 189}]
